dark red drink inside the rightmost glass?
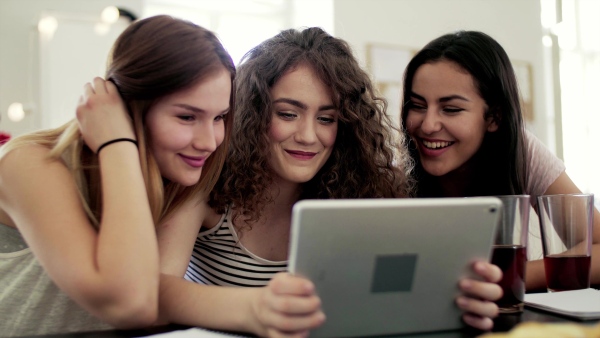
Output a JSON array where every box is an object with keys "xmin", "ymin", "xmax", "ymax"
[{"xmin": 544, "ymin": 254, "xmax": 592, "ymax": 291}]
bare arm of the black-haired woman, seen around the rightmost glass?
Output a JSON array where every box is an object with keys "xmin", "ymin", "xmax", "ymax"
[{"xmin": 525, "ymin": 172, "xmax": 600, "ymax": 291}]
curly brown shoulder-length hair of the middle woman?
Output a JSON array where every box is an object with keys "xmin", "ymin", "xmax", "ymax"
[{"xmin": 209, "ymin": 27, "xmax": 413, "ymax": 221}]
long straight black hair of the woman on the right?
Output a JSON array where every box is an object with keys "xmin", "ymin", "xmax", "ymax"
[{"xmin": 401, "ymin": 31, "xmax": 527, "ymax": 197}]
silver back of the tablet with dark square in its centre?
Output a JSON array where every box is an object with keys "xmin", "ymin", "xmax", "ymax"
[{"xmin": 289, "ymin": 197, "xmax": 502, "ymax": 337}]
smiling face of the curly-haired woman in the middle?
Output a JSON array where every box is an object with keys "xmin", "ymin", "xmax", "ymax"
[{"xmin": 268, "ymin": 64, "xmax": 338, "ymax": 183}]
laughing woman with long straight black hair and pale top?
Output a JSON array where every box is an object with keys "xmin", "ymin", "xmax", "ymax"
[{"xmin": 401, "ymin": 31, "xmax": 600, "ymax": 290}]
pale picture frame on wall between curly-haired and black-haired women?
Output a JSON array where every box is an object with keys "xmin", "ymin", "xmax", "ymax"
[{"xmin": 367, "ymin": 43, "xmax": 415, "ymax": 125}]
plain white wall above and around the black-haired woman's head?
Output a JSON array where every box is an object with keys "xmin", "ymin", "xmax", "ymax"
[{"xmin": 334, "ymin": 0, "xmax": 553, "ymax": 149}]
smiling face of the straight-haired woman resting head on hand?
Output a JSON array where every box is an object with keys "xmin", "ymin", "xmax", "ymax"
[{"xmin": 146, "ymin": 69, "xmax": 231, "ymax": 186}]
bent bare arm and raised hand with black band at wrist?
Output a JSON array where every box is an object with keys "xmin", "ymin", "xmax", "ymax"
[{"xmin": 0, "ymin": 79, "xmax": 159, "ymax": 327}]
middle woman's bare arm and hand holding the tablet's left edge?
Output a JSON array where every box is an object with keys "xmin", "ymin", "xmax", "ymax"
[{"xmin": 158, "ymin": 202, "xmax": 324, "ymax": 336}]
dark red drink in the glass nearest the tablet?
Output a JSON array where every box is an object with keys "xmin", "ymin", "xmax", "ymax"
[{"xmin": 491, "ymin": 245, "xmax": 527, "ymax": 313}]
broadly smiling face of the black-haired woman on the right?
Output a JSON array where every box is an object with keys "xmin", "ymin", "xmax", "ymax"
[{"xmin": 406, "ymin": 60, "xmax": 498, "ymax": 176}]
